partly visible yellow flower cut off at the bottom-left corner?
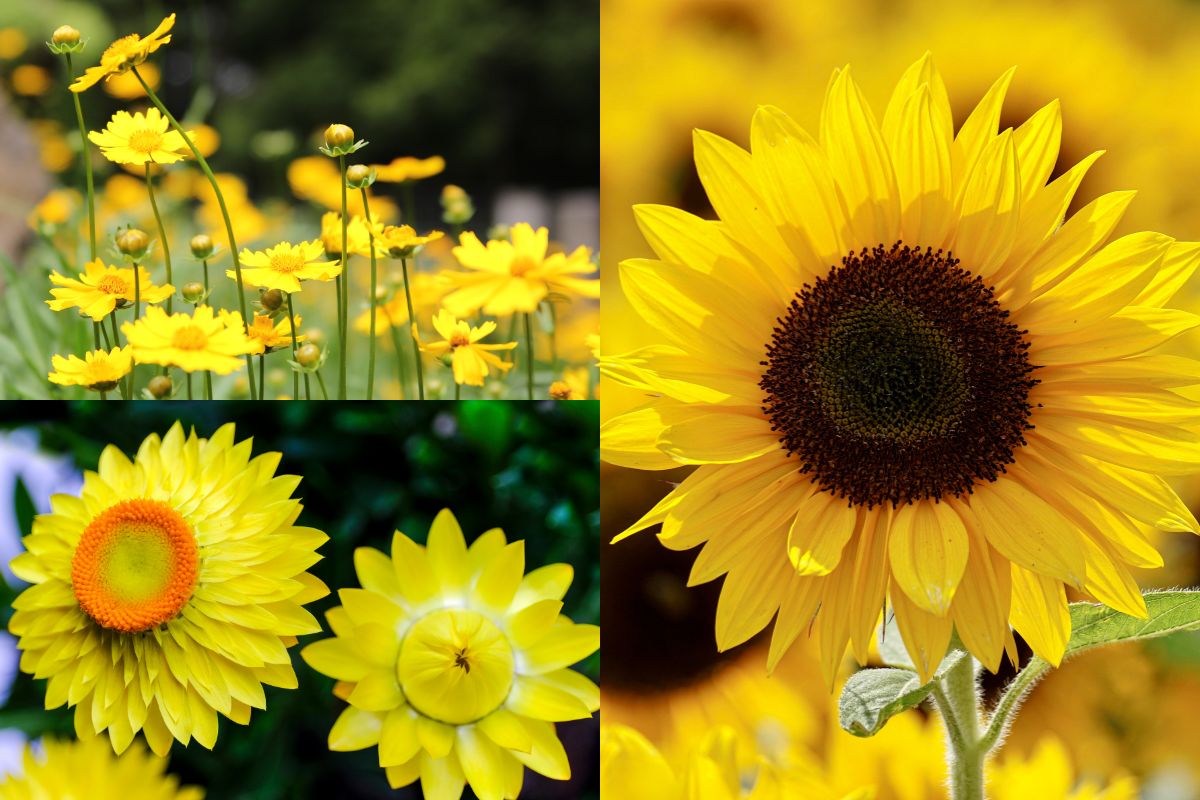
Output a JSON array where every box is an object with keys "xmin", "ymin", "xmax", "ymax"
[{"xmin": 0, "ymin": 736, "xmax": 204, "ymax": 800}]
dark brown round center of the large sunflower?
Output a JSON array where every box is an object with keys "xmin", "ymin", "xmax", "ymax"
[{"xmin": 760, "ymin": 242, "xmax": 1037, "ymax": 507}]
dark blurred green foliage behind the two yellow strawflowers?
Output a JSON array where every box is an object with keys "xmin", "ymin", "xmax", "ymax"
[{"xmin": 0, "ymin": 402, "xmax": 600, "ymax": 800}]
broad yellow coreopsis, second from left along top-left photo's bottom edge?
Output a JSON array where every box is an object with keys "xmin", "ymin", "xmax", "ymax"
[{"xmin": 121, "ymin": 306, "xmax": 257, "ymax": 375}]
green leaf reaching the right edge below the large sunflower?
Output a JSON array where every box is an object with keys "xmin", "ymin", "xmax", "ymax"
[{"xmin": 1064, "ymin": 590, "xmax": 1200, "ymax": 657}]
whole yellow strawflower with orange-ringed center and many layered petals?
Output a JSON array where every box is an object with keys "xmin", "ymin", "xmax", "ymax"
[{"xmin": 8, "ymin": 422, "xmax": 329, "ymax": 756}]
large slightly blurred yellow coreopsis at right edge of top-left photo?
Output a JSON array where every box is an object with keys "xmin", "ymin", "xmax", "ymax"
[{"xmin": 445, "ymin": 222, "xmax": 600, "ymax": 317}]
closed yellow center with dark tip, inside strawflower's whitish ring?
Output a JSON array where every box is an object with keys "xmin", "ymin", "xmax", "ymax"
[{"xmin": 396, "ymin": 608, "xmax": 515, "ymax": 724}]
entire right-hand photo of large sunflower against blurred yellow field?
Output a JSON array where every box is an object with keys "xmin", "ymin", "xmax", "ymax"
[{"xmin": 600, "ymin": 0, "xmax": 1200, "ymax": 800}]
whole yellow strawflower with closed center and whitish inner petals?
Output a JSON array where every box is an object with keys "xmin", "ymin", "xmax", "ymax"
[{"xmin": 300, "ymin": 510, "xmax": 600, "ymax": 800}]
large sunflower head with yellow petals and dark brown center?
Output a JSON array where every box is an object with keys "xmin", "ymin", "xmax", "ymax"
[{"xmin": 601, "ymin": 55, "xmax": 1200, "ymax": 682}]
